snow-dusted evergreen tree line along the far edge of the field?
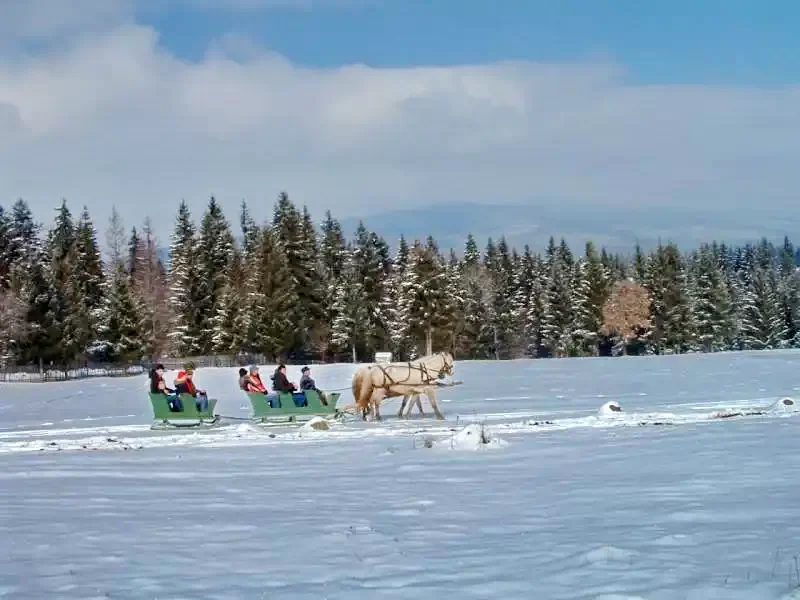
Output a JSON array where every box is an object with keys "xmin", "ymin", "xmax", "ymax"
[{"xmin": 0, "ymin": 193, "xmax": 800, "ymax": 365}]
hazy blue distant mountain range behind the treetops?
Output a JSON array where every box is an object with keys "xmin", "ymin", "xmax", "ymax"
[{"xmin": 159, "ymin": 203, "xmax": 800, "ymax": 265}]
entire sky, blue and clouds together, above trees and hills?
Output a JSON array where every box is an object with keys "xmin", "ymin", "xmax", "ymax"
[{"xmin": 0, "ymin": 0, "xmax": 800, "ymax": 248}]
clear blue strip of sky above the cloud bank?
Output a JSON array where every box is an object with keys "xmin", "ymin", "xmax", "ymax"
[{"xmin": 139, "ymin": 0, "xmax": 800, "ymax": 85}]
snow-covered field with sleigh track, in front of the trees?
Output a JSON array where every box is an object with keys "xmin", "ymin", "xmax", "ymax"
[{"xmin": 0, "ymin": 351, "xmax": 800, "ymax": 600}]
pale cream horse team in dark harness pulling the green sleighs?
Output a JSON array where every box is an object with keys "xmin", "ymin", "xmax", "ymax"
[{"xmin": 352, "ymin": 352, "xmax": 454, "ymax": 421}]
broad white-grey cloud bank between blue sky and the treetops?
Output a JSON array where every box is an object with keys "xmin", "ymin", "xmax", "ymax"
[{"xmin": 0, "ymin": 20, "xmax": 800, "ymax": 244}]
